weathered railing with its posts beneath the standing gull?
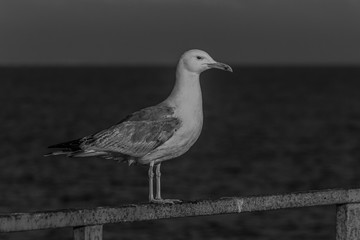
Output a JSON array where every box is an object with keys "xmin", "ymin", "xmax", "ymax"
[{"xmin": 0, "ymin": 189, "xmax": 360, "ymax": 240}]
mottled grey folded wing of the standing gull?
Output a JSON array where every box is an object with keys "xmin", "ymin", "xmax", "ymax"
[{"xmin": 80, "ymin": 105, "xmax": 181, "ymax": 158}]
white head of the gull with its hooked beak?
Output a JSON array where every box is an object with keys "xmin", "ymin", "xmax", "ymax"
[{"xmin": 179, "ymin": 49, "xmax": 232, "ymax": 74}]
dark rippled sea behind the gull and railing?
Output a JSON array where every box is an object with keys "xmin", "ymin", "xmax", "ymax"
[{"xmin": 0, "ymin": 67, "xmax": 360, "ymax": 240}]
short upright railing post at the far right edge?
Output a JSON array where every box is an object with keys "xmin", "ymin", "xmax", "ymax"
[{"xmin": 336, "ymin": 203, "xmax": 360, "ymax": 240}]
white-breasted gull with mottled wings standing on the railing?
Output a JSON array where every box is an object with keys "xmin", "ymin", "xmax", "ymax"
[{"xmin": 44, "ymin": 49, "xmax": 232, "ymax": 204}]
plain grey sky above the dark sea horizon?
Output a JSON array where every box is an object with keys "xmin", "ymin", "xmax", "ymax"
[{"xmin": 0, "ymin": 0, "xmax": 360, "ymax": 65}]
